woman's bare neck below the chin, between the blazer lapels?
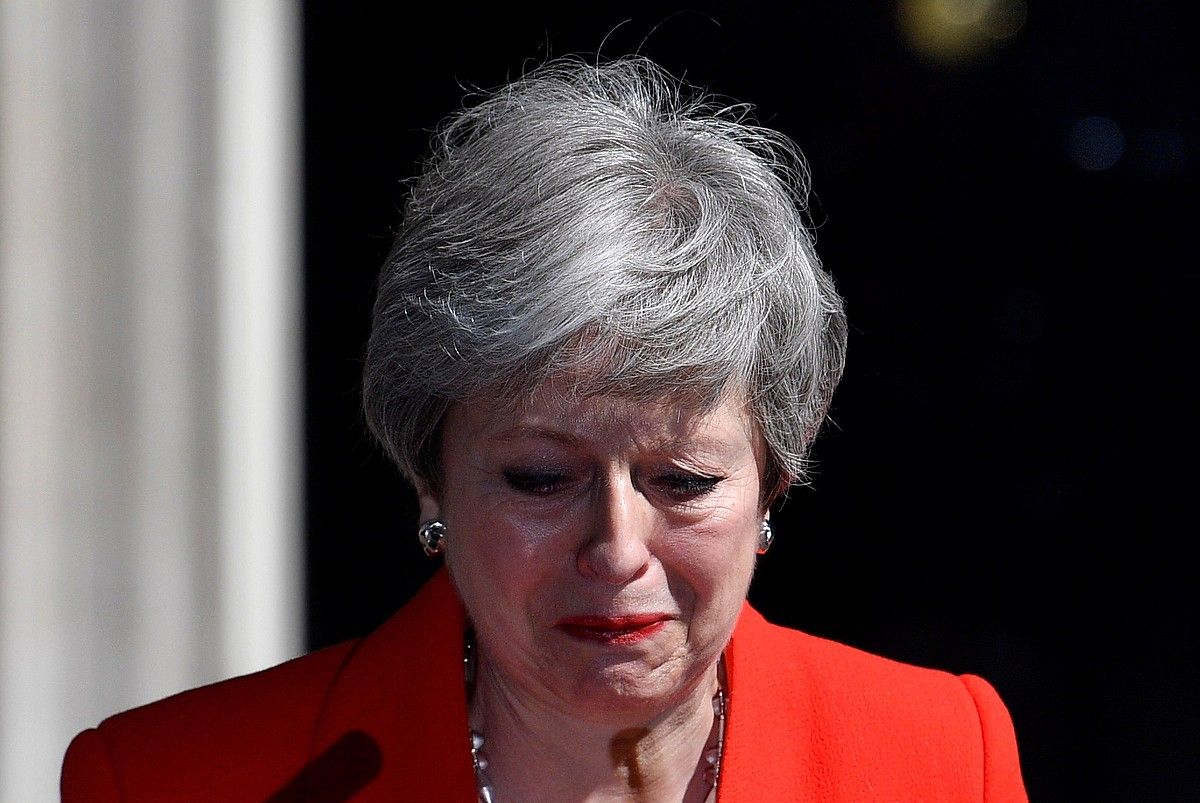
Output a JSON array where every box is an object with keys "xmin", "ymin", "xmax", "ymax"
[{"xmin": 470, "ymin": 657, "xmax": 719, "ymax": 803}]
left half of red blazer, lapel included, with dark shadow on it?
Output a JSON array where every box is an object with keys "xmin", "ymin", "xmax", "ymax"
[{"xmin": 61, "ymin": 570, "xmax": 475, "ymax": 803}]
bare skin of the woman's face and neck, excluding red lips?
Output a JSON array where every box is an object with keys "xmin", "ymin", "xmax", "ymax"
[{"xmin": 420, "ymin": 388, "xmax": 767, "ymax": 801}]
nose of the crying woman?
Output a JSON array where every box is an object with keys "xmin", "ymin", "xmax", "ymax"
[{"xmin": 576, "ymin": 477, "xmax": 654, "ymax": 586}]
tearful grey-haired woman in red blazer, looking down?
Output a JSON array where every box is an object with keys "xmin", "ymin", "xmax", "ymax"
[{"xmin": 64, "ymin": 59, "xmax": 1025, "ymax": 803}]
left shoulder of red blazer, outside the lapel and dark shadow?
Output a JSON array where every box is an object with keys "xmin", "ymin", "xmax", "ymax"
[{"xmin": 62, "ymin": 641, "xmax": 358, "ymax": 801}]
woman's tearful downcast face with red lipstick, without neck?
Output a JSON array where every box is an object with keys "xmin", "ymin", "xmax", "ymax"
[{"xmin": 421, "ymin": 391, "xmax": 764, "ymax": 719}]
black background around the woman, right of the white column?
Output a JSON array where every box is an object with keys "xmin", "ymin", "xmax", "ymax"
[{"xmin": 304, "ymin": 0, "xmax": 1200, "ymax": 801}]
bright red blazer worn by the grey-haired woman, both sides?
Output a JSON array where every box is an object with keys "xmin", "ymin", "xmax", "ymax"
[{"xmin": 62, "ymin": 570, "xmax": 1026, "ymax": 803}]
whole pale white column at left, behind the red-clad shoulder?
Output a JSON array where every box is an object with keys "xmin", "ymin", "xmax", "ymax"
[{"xmin": 0, "ymin": 0, "xmax": 302, "ymax": 803}]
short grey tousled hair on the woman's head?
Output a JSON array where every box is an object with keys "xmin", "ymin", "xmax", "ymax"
[{"xmin": 364, "ymin": 58, "xmax": 846, "ymax": 501}]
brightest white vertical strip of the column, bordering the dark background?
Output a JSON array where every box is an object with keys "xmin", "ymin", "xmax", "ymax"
[{"xmin": 217, "ymin": 0, "xmax": 304, "ymax": 672}]
